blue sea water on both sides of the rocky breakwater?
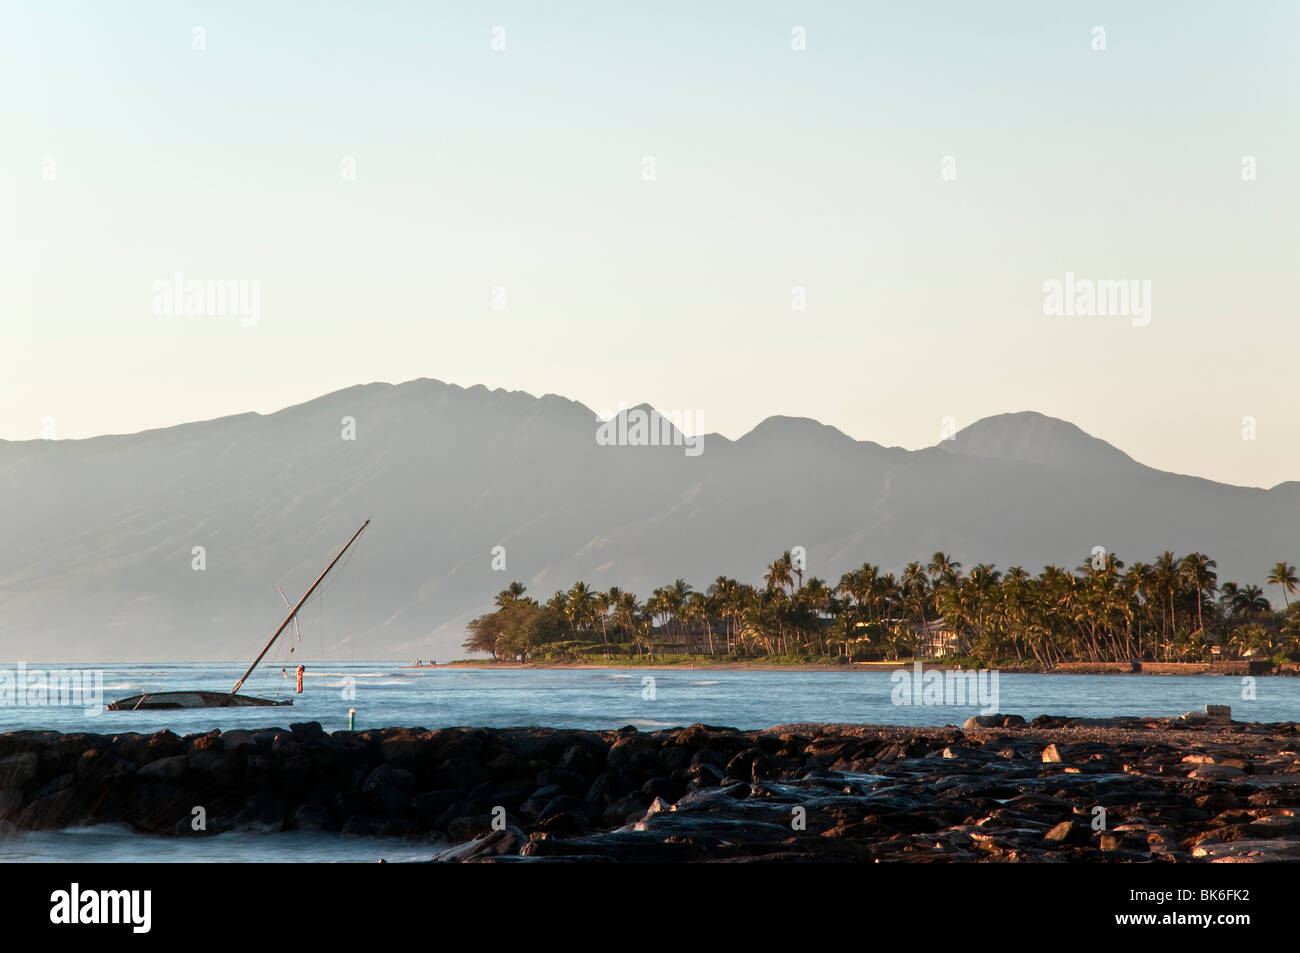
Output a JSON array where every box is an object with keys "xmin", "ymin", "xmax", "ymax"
[{"xmin": 0, "ymin": 662, "xmax": 1300, "ymax": 862}]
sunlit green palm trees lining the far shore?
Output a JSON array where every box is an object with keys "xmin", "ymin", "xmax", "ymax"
[{"xmin": 464, "ymin": 550, "xmax": 1300, "ymax": 668}]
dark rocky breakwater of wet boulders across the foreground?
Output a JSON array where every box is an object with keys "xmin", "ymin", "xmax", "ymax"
[{"xmin": 0, "ymin": 715, "xmax": 1300, "ymax": 863}]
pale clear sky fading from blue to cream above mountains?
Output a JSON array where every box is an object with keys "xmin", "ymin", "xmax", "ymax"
[{"xmin": 0, "ymin": 0, "xmax": 1300, "ymax": 486}]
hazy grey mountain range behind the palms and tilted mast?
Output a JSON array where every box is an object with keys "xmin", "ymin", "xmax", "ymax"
[{"xmin": 0, "ymin": 380, "xmax": 1300, "ymax": 660}]
